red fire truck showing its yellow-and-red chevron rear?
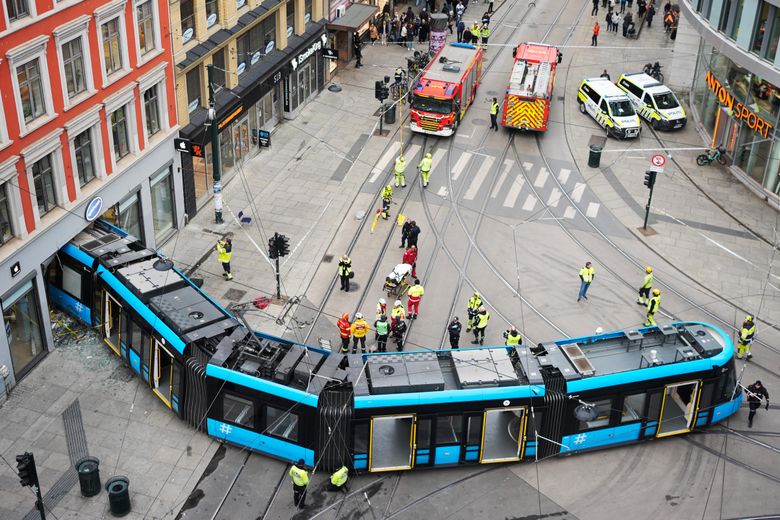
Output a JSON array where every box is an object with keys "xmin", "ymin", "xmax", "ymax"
[{"xmin": 501, "ymin": 43, "xmax": 558, "ymax": 132}]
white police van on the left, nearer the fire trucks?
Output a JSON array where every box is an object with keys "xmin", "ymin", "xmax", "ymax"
[{"xmin": 577, "ymin": 78, "xmax": 641, "ymax": 139}]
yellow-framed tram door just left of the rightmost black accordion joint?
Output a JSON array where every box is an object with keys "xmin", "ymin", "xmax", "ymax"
[{"xmin": 479, "ymin": 406, "xmax": 528, "ymax": 464}]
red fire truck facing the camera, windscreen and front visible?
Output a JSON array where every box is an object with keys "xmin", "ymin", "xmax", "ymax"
[{"xmin": 411, "ymin": 43, "xmax": 482, "ymax": 136}]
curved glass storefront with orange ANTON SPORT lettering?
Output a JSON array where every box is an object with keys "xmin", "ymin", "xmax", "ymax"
[{"xmin": 692, "ymin": 42, "xmax": 780, "ymax": 195}]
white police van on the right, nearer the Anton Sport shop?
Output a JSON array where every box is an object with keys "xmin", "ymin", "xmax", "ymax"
[{"xmin": 617, "ymin": 72, "xmax": 688, "ymax": 130}]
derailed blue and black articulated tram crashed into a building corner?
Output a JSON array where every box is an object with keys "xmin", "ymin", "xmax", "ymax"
[{"xmin": 47, "ymin": 221, "xmax": 742, "ymax": 472}]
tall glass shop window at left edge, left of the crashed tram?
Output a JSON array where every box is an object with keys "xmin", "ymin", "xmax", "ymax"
[{"xmin": 2, "ymin": 280, "xmax": 46, "ymax": 380}]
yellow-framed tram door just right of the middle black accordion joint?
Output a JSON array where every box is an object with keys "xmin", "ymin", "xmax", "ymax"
[{"xmin": 368, "ymin": 414, "xmax": 417, "ymax": 472}]
